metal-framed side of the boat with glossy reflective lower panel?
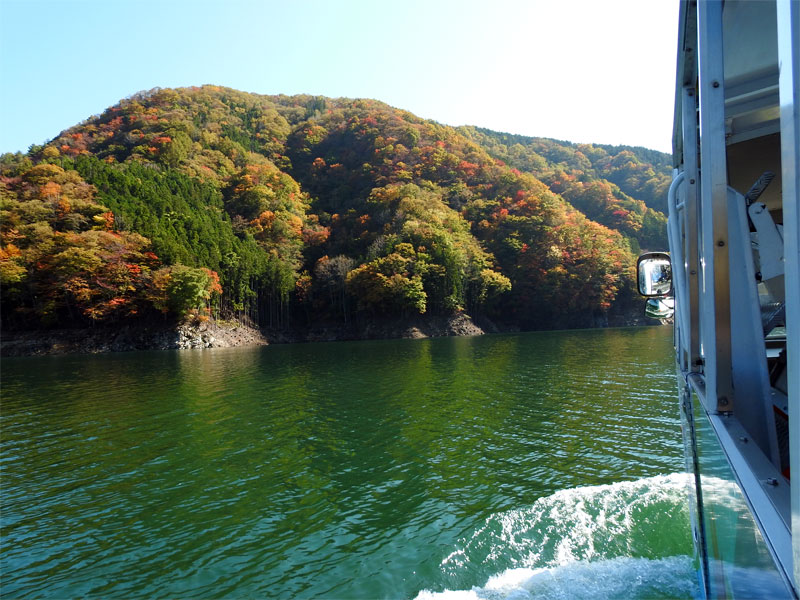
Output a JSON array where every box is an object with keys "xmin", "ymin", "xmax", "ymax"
[{"xmin": 640, "ymin": 0, "xmax": 800, "ymax": 598}]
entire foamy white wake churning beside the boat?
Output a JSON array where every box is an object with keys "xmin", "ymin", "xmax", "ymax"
[{"xmin": 417, "ymin": 473, "xmax": 699, "ymax": 600}]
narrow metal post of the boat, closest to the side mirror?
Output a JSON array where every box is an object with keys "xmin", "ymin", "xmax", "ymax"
[{"xmin": 681, "ymin": 86, "xmax": 702, "ymax": 373}]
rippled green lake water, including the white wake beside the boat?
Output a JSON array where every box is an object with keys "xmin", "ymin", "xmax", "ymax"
[{"xmin": 0, "ymin": 327, "xmax": 697, "ymax": 599}]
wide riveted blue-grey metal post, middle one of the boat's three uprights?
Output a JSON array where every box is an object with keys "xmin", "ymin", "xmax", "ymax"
[{"xmin": 697, "ymin": 0, "xmax": 733, "ymax": 412}]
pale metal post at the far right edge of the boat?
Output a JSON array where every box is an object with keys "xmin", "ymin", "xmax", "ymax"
[{"xmin": 777, "ymin": 0, "xmax": 800, "ymax": 591}]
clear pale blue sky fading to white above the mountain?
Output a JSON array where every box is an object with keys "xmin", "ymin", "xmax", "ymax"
[{"xmin": 0, "ymin": 0, "xmax": 678, "ymax": 152}]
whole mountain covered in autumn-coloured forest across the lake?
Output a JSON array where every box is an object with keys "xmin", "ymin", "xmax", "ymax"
[{"xmin": 0, "ymin": 86, "xmax": 669, "ymax": 328}]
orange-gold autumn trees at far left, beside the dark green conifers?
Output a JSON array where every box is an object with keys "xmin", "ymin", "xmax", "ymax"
[{"xmin": 0, "ymin": 164, "xmax": 222, "ymax": 326}]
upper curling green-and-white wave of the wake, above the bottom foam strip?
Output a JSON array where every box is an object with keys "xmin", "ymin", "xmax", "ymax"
[{"xmin": 450, "ymin": 473, "xmax": 690, "ymax": 569}]
